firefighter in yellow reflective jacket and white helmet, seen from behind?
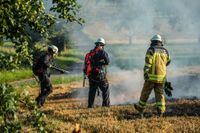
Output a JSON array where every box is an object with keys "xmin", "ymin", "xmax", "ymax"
[{"xmin": 134, "ymin": 35, "xmax": 170, "ymax": 116}]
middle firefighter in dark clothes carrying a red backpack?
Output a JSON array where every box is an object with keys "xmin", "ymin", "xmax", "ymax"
[{"xmin": 83, "ymin": 38, "xmax": 110, "ymax": 108}]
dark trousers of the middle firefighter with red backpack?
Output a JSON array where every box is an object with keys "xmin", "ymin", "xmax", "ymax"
[{"xmin": 88, "ymin": 79, "xmax": 110, "ymax": 108}]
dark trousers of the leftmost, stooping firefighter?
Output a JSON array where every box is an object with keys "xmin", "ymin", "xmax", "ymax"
[{"xmin": 36, "ymin": 74, "xmax": 52, "ymax": 106}]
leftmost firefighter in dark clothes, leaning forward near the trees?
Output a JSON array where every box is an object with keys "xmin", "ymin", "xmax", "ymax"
[{"xmin": 34, "ymin": 45, "xmax": 58, "ymax": 106}]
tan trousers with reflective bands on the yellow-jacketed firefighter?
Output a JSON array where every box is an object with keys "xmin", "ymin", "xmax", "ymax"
[{"xmin": 139, "ymin": 80, "xmax": 165, "ymax": 113}]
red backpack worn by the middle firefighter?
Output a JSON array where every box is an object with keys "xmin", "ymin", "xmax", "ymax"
[{"xmin": 83, "ymin": 49, "xmax": 100, "ymax": 76}]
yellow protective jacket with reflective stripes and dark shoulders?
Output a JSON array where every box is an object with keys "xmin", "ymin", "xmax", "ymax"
[{"xmin": 144, "ymin": 43, "xmax": 170, "ymax": 83}]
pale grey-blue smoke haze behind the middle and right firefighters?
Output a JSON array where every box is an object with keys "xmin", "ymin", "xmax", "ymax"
[{"xmin": 64, "ymin": 0, "xmax": 200, "ymax": 104}]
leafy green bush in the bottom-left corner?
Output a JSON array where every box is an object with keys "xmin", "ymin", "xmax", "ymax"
[{"xmin": 0, "ymin": 84, "xmax": 21, "ymax": 133}]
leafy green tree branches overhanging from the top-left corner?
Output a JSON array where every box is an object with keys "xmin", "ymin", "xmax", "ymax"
[{"xmin": 0, "ymin": 0, "xmax": 84, "ymax": 69}]
